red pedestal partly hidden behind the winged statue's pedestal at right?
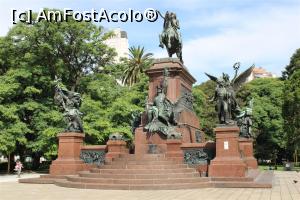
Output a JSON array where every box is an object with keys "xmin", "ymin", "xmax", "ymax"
[{"xmin": 239, "ymin": 138, "xmax": 257, "ymax": 169}]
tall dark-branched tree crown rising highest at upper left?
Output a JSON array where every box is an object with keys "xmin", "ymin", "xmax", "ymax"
[{"xmin": 8, "ymin": 10, "xmax": 116, "ymax": 91}]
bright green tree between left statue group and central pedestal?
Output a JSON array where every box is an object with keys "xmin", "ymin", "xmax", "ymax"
[{"xmin": 81, "ymin": 73, "xmax": 148, "ymax": 144}]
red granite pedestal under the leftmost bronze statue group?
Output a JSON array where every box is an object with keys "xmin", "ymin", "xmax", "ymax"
[{"xmin": 50, "ymin": 132, "xmax": 87, "ymax": 175}]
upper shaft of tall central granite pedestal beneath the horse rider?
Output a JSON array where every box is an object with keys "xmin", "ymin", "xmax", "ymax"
[{"xmin": 142, "ymin": 58, "xmax": 204, "ymax": 143}]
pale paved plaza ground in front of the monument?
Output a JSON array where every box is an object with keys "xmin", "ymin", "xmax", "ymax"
[{"xmin": 0, "ymin": 171, "xmax": 300, "ymax": 200}]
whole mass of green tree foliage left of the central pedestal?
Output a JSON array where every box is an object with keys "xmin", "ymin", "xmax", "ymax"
[{"xmin": 0, "ymin": 9, "xmax": 147, "ymax": 170}]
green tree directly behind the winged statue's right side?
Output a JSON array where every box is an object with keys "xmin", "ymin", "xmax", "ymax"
[{"xmin": 237, "ymin": 78, "xmax": 287, "ymax": 159}]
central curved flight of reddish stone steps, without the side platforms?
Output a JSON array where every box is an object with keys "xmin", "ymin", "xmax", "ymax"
[{"xmin": 54, "ymin": 154, "xmax": 212, "ymax": 190}]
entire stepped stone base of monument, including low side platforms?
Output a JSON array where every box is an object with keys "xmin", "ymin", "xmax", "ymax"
[{"xmin": 19, "ymin": 154, "xmax": 273, "ymax": 190}]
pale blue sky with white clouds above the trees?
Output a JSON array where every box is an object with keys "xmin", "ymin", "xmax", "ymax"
[{"xmin": 0, "ymin": 0, "xmax": 300, "ymax": 82}]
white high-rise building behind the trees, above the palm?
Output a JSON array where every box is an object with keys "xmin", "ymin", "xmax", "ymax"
[{"xmin": 105, "ymin": 28, "xmax": 129, "ymax": 63}]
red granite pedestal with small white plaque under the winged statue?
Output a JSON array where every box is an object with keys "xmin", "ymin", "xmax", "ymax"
[{"xmin": 208, "ymin": 126, "xmax": 247, "ymax": 177}]
